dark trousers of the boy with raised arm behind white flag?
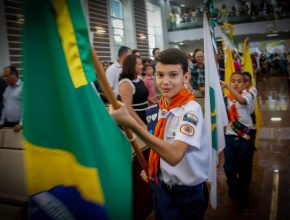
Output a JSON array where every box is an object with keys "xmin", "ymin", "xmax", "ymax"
[{"xmin": 224, "ymin": 135, "xmax": 254, "ymax": 208}]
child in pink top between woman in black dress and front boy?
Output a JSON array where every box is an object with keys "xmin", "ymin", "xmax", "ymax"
[{"xmin": 143, "ymin": 64, "xmax": 158, "ymax": 106}]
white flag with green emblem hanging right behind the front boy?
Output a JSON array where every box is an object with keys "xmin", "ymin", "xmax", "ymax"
[{"xmin": 203, "ymin": 13, "xmax": 228, "ymax": 209}]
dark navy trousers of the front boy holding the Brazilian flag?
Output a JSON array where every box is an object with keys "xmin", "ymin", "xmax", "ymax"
[{"xmin": 153, "ymin": 182, "xmax": 208, "ymax": 220}]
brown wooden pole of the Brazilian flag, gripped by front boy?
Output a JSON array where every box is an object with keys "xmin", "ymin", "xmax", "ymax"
[{"xmin": 91, "ymin": 47, "xmax": 148, "ymax": 174}]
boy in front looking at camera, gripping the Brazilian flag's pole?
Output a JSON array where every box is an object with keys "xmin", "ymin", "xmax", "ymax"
[{"xmin": 110, "ymin": 49, "xmax": 209, "ymax": 220}]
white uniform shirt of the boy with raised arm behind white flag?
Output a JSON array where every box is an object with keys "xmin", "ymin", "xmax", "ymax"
[{"xmin": 226, "ymin": 90, "xmax": 254, "ymax": 135}]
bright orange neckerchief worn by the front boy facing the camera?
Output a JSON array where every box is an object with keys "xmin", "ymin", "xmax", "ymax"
[{"xmin": 148, "ymin": 89, "xmax": 194, "ymax": 184}]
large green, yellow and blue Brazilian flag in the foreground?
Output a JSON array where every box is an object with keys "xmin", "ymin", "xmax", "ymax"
[{"xmin": 23, "ymin": 0, "xmax": 132, "ymax": 219}]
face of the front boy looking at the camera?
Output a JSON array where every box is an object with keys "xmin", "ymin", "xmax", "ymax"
[{"xmin": 156, "ymin": 62, "xmax": 190, "ymax": 102}]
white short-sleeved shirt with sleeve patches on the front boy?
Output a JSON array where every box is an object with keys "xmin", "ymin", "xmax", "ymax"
[{"xmin": 158, "ymin": 101, "xmax": 209, "ymax": 186}]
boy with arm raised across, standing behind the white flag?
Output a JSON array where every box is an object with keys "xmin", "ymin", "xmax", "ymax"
[{"xmin": 221, "ymin": 72, "xmax": 254, "ymax": 210}]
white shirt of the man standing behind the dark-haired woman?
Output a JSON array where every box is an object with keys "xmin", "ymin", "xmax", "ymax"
[{"xmin": 106, "ymin": 61, "xmax": 122, "ymax": 97}]
